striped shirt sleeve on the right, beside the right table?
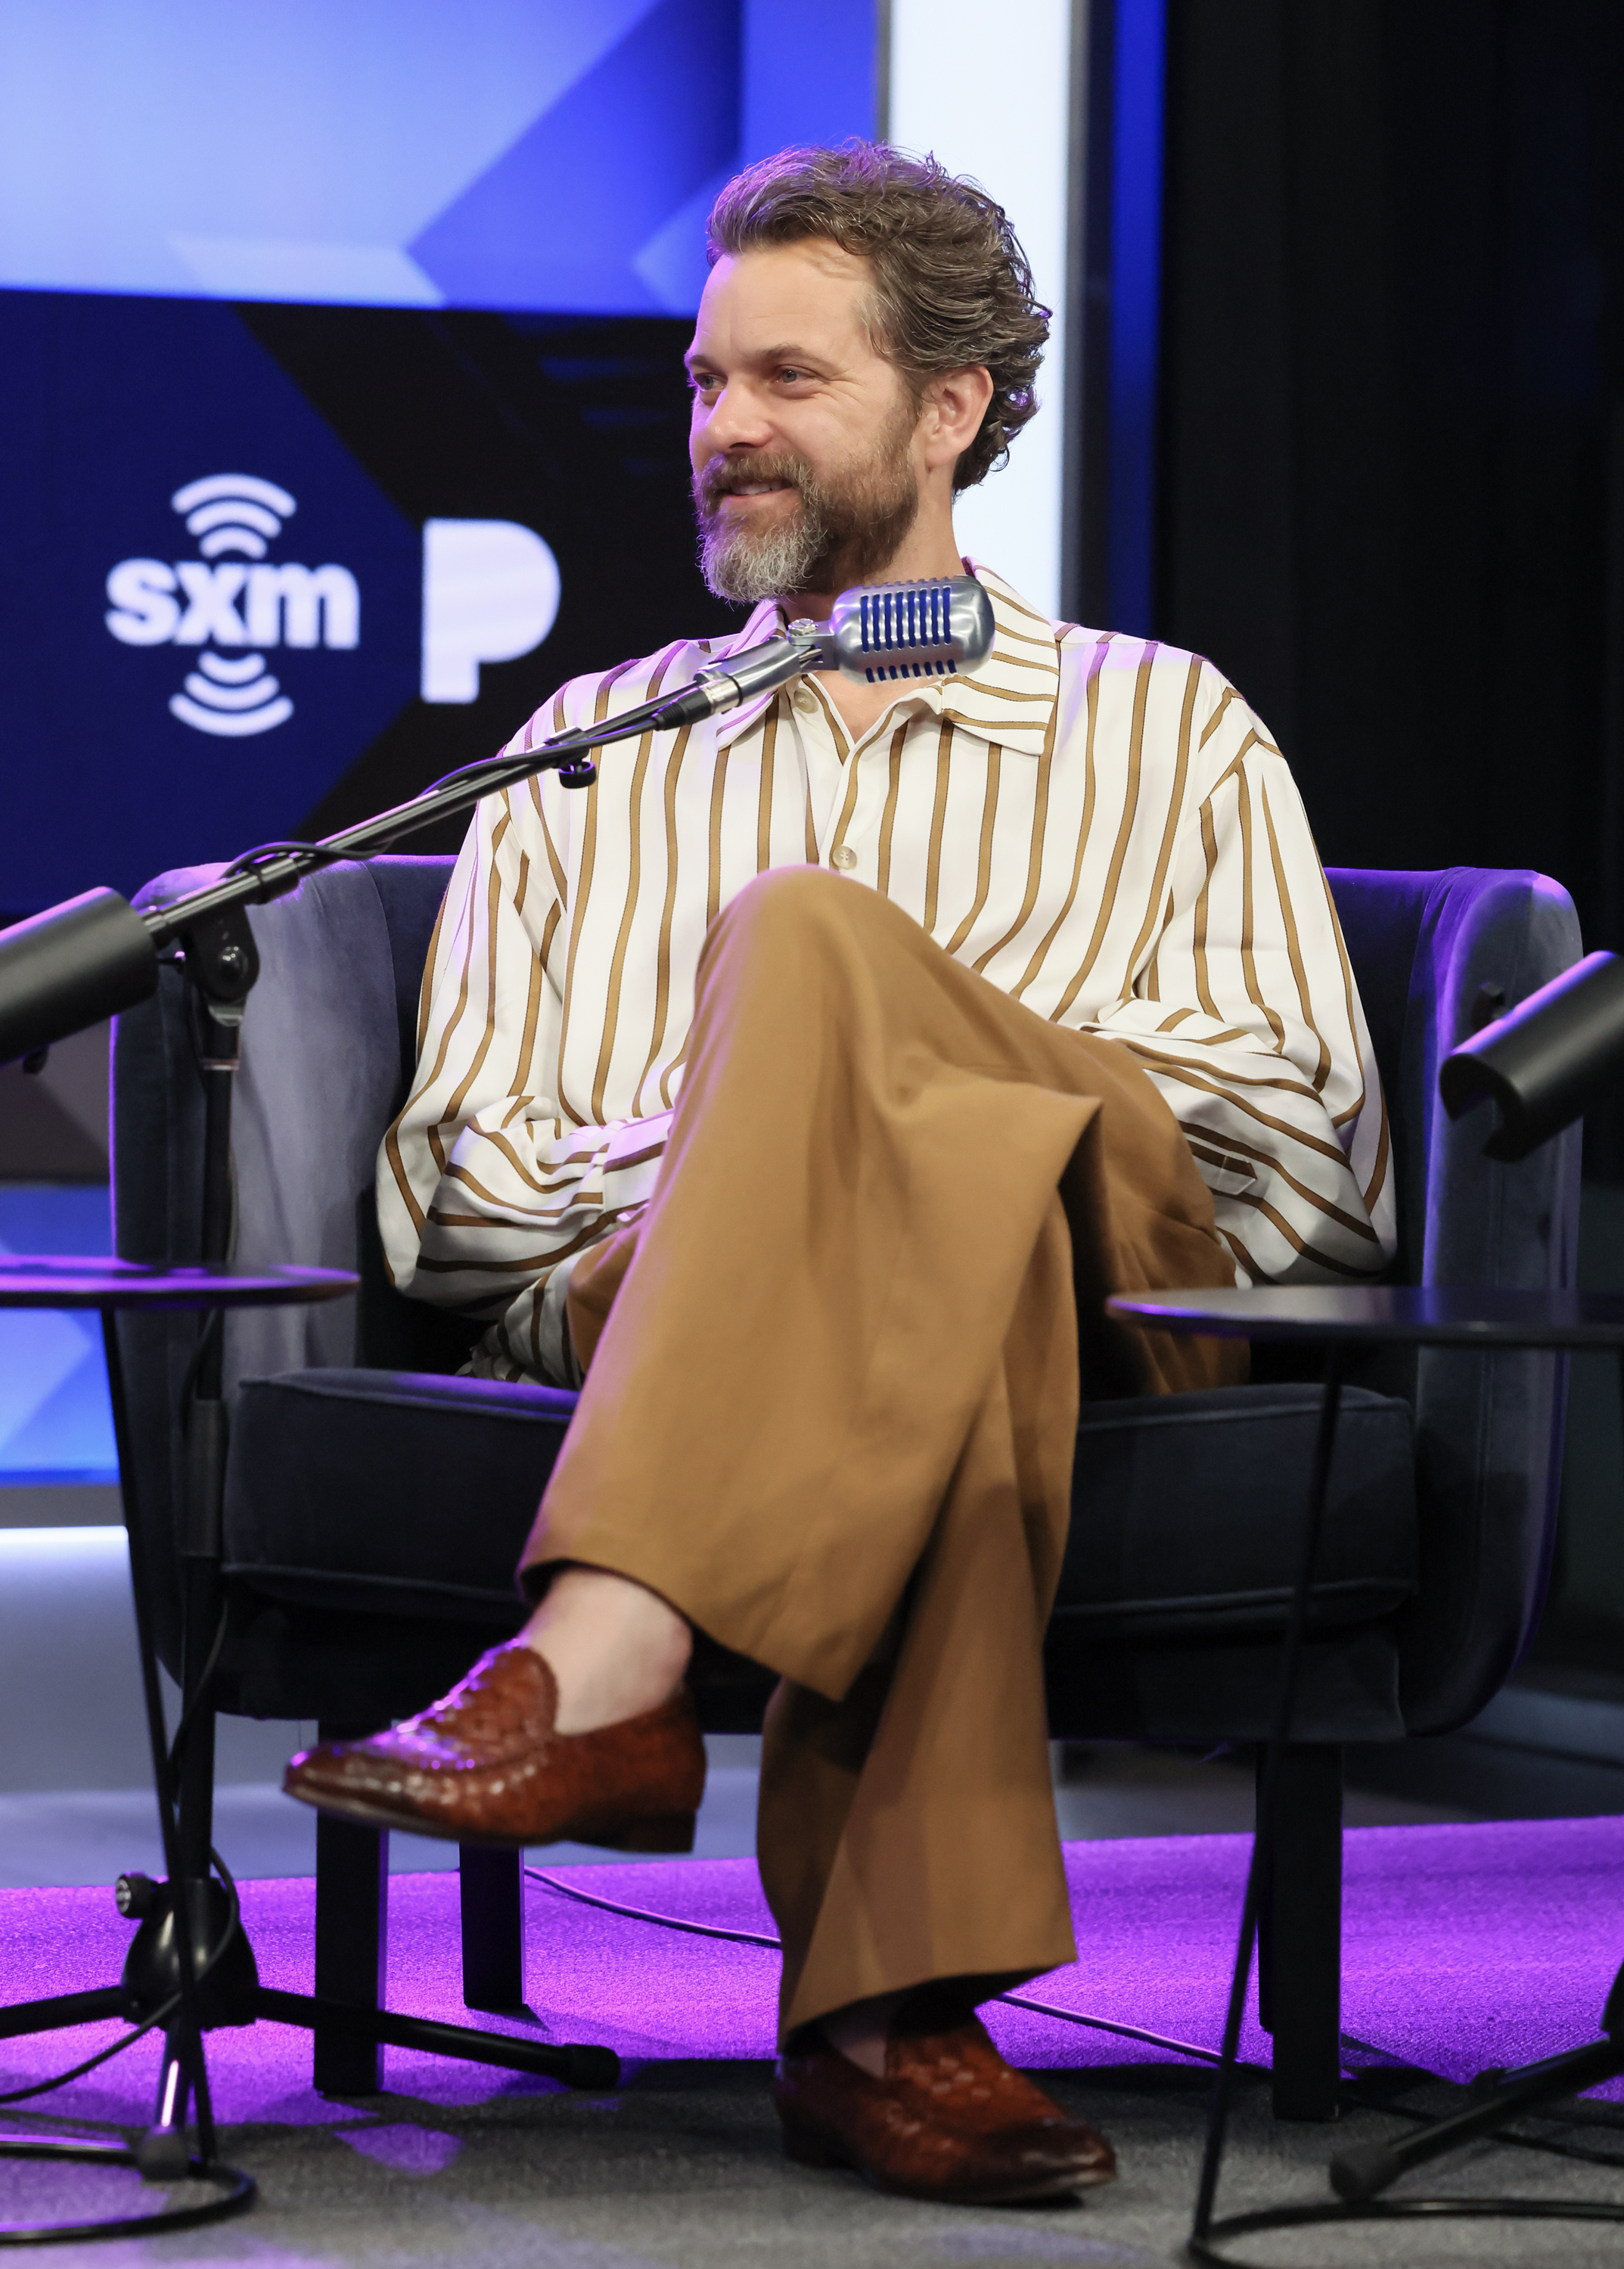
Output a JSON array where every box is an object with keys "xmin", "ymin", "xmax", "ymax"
[{"xmin": 1095, "ymin": 674, "xmax": 1397, "ymax": 1284}]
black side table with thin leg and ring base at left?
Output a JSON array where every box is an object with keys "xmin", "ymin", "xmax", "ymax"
[{"xmin": 0, "ymin": 1255, "xmax": 359, "ymax": 2244}]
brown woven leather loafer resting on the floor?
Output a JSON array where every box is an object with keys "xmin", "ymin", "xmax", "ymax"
[{"xmin": 774, "ymin": 2017, "xmax": 1116, "ymax": 2205}]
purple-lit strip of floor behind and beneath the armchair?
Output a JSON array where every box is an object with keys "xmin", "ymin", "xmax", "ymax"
[{"xmin": 0, "ymin": 1820, "xmax": 1624, "ymax": 2124}]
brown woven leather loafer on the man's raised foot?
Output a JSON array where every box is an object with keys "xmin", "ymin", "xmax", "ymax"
[{"xmin": 281, "ymin": 1638, "xmax": 706, "ymax": 1852}]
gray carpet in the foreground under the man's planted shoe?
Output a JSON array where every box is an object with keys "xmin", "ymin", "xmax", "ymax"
[{"xmin": 0, "ymin": 2063, "xmax": 1624, "ymax": 2269}]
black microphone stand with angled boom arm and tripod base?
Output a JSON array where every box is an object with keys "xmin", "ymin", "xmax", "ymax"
[{"xmin": 0, "ymin": 649, "xmax": 823, "ymax": 2181}]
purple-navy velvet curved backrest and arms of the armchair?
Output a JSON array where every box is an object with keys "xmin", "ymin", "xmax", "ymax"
[{"xmin": 113, "ymin": 858, "xmax": 1579, "ymax": 1729}]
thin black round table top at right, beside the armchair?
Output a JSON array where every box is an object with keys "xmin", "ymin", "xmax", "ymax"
[{"xmin": 1104, "ymin": 1284, "xmax": 1624, "ymax": 1348}]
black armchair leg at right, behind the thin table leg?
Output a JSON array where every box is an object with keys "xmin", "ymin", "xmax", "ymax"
[{"xmin": 1256, "ymin": 1743, "xmax": 1343, "ymax": 2119}]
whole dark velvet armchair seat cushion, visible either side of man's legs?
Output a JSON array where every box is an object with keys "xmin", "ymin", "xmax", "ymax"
[{"xmin": 225, "ymin": 1370, "xmax": 1415, "ymax": 1645}]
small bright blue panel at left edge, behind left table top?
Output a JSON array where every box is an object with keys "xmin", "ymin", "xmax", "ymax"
[{"xmin": 0, "ymin": 1182, "xmax": 118, "ymax": 1486}]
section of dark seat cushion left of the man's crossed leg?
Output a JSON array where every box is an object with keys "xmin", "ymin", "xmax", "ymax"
[{"xmin": 225, "ymin": 1370, "xmax": 576, "ymax": 1625}]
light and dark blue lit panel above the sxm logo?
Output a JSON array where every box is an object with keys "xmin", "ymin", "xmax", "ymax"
[{"xmin": 0, "ymin": 0, "xmax": 877, "ymax": 315}]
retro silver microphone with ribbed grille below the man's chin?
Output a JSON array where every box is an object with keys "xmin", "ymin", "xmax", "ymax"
[{"xmin": 654, "ymin": 574, "xmax": 993, "ymax": 731}]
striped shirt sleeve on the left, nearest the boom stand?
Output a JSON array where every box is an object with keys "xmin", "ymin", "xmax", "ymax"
[{"xmin": 377, "ymin": 787, "xmax": 672, "ymax": 1384}]
